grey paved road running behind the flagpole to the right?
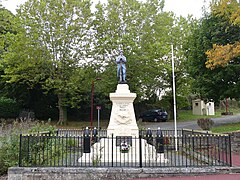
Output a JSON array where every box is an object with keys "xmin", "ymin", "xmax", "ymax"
[{"xmin": 141, "ymin": 115, "xmax": 240, "ymax": 129}]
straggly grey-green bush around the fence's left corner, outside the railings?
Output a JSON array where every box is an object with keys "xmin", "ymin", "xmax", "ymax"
[{"xmin": 0, "ymin": 120, "xmax": 55, "ymax": 174}]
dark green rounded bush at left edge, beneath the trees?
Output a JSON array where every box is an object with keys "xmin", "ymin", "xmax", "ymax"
[{"xmin": 0, "ymin": 97, "xmax": 19, "ymax": 118}]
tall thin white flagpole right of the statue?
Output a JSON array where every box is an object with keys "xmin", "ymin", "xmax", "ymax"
[{"xmin": 171, "ymin": 45, "xmax": 178, "ymax": 151}]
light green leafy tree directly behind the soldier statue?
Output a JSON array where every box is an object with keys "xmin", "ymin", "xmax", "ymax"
[{"xmin": 94, "ymin": 0, "xmax": 191, "ymax": 107}]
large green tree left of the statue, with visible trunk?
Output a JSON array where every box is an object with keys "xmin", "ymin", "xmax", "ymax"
[{"xmin": 3, "ymin": 0, "xmax": 92, "ymax": 123}]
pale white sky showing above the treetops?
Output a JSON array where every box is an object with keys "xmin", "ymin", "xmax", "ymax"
[{"xmin": 2, "ymin": 0, "xmax": 210, "ymax": 18}]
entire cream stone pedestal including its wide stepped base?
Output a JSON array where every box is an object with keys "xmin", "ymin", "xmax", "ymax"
[{"xmin": 78, "ymin": 84, "xmax": 168, "ymax": 166}]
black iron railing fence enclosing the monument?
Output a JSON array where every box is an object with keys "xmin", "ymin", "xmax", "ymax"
[{"xmin": 19, "ymin": 130, "xmax": 232, "ymax": 167}]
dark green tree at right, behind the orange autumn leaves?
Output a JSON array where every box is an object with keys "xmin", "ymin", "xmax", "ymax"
[{"xmin": 186, "ymin": 14, "xmax": 240, "ymax": 101}]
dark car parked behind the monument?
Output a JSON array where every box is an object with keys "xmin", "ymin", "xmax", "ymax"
[{"xmin": 139, "ymin": 109, "xmax": 168, "ymax": 122}]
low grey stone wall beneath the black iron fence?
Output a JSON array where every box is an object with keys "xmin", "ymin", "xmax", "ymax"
[{"xmin": 8, "ymin": 167, "xmax": 240, "ymax": 180}]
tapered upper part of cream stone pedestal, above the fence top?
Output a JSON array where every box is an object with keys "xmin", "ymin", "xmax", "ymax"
[{"xmin": 107, "ymin": 84, "xmax": 139, "ymax": 137}]
